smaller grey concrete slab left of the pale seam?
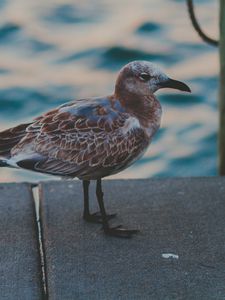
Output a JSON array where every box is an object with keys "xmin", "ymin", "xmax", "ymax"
[{"xmin": 0, "ymin": 183, "xmax": 42, "ymax": 300}]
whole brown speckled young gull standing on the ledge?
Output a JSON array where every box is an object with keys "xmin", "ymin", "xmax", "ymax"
[{"xmin": 0, "ymin": 61, "xmax": 191, "ymax": 238}]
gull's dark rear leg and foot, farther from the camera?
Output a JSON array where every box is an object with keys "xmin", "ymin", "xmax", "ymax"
[{"xmin": 83, "ymin": 180, "xmax": 116, "ymax": 223}]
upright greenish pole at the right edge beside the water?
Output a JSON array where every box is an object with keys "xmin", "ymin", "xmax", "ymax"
[{"xmin": 219, "ymin": 0, "xmax": 225, "ymax": 175}]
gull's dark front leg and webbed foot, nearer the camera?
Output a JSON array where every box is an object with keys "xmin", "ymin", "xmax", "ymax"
[{"xmin": 96, "ymin": 179, "xmax": 138, "ymax": 238}]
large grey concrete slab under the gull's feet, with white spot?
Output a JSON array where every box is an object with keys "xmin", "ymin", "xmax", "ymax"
[{"xmin": 41, "ymin": 178, "xmax": 225, "ymax": 300}]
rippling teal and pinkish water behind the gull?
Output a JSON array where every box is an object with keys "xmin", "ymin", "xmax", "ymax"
[{"xmin": 0, "ymin": 0, "xmax": 219, "ymax": 181}]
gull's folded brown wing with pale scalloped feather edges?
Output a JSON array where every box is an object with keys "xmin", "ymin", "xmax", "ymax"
[{"xmin": 13, "ymin": 97, "xmax": 148, "ymax": 177}]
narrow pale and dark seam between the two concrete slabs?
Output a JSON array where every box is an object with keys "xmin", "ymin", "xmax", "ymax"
[{"xmin": 32, "ymin": 185, "xmax": 48, "ymax": 300}]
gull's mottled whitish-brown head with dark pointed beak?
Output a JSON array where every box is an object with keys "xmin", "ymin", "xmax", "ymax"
[{"xmin": 115, "ymin": 61, "xmax": 191, "ymax": 96}]
